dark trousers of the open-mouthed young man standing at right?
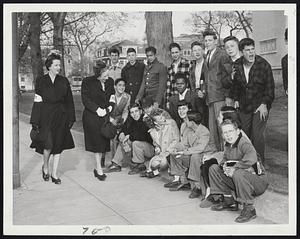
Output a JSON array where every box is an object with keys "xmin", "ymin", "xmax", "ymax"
[{"xmin": 240, "ymin": 112, "xmax": 267, "ymax": 165}]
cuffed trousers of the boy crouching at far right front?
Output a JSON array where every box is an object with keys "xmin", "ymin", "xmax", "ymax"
[{"xmin": 209, "ymin": 164, "xmax": 269, "ymax": 204}]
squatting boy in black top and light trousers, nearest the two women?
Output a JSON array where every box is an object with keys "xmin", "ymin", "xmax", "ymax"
[{"xmin": 106, "ymin": 103, "xmax": 154, "ymax": 174}]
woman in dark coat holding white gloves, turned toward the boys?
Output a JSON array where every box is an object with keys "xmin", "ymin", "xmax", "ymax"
[{"xmin": 81, "ymin": 61, "xmax": 115, "ymax": 181}]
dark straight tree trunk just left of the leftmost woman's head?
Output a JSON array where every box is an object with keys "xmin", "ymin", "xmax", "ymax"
[{"xmin": 29, "ymin": 12, "xmax": 44, "ymax": 85}]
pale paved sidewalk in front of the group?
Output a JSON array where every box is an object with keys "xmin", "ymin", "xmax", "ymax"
[{"xmin": 13, "ymin": 114, "xmax": 289, "ymax": 225}]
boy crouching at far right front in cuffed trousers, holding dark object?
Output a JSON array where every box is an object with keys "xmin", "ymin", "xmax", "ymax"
[{"xmin": 205, "ymin": 119, "xmax": 268, "ymax": 222}]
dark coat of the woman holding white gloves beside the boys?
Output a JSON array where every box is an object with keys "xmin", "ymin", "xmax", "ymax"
[{"xmin": 81, "ymin": 76, "xmax": 115, "ymax": 153}]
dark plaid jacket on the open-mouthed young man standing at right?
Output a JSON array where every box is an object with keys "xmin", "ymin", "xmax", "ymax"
[{"xmin": 230, "ymin": 55, "xmax": 274, "ymax": 113}]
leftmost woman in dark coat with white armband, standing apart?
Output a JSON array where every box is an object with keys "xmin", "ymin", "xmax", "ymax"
[{"xmin": 30, "ymin": 53, "xmax": 75, "ymax": 184}]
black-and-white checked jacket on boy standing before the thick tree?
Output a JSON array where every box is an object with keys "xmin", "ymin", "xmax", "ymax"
[{"xmin": 166, "ymin": 58, "xmax": 190, "ymax": 103}]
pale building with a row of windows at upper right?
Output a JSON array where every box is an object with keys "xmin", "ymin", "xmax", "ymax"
[{"xmin": 252, "ymin": 11, "xmax": 288, "ymax": 76}]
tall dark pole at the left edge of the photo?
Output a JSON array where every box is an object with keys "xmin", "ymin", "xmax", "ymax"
[{"xmin": 12, "ymin": 13, "xmax": 21, "ymax": 189}]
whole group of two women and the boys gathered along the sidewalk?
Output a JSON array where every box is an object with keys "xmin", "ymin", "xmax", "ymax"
[{"xmin": 30, "ymin": 31, "xmax": 282, "ymax": 222}]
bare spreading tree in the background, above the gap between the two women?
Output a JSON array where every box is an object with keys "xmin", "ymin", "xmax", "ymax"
[{"xmin": 64, "ymin": 12, "xmax": 127, "ymax": 73}]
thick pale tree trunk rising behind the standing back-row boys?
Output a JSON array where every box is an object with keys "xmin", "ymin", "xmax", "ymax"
[{"xmin": 145, "ymin": 12, "xmax": 173, "ymax": 66}]
